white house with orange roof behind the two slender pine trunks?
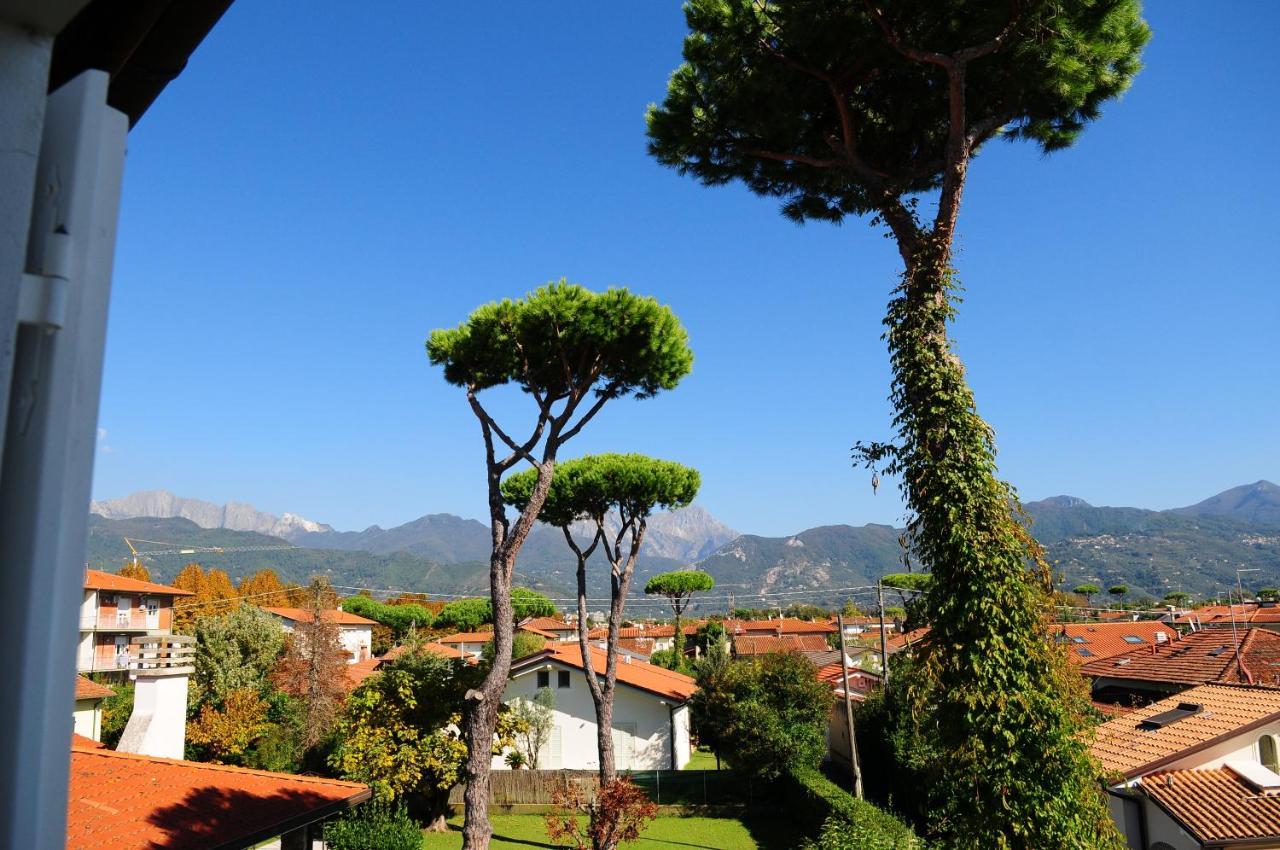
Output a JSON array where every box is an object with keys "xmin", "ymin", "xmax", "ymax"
[{"xmin": 493, "ymin": 643, "xmax": 698, "ymax": 771}]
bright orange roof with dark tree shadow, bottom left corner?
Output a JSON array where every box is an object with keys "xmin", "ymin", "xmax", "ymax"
[{"xmin": 67, "ymin": 745, "xmax": 369, "ymax": 850}]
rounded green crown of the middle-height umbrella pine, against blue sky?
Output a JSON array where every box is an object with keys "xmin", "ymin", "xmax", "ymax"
[{"xmin": 426, "ymin": 280, "xmax": 694, "ymax": 402}]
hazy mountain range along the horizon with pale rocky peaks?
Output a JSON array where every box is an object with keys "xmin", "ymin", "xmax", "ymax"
[{"xmin": 90, "ymin": 481, "xmax": 1280, "ymax": 603}]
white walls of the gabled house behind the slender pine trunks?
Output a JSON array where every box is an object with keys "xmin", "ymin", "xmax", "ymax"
[{"xmin": 493, "ymin": 662, "xmax": 690, "ymax": 771}]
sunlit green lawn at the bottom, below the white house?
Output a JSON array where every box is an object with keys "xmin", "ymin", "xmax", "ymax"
[{"xmin": 422, "ymin": 814, "xmax": 799, "ymax": 850}]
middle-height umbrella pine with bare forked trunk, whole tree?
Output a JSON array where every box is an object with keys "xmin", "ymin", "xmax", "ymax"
[{"xmin": 426, "ymin": 282, "xmax": 692, "ymax": 850}]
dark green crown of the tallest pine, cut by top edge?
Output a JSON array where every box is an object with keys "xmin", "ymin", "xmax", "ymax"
[{"xmin": 648, "ymin": 0, "xmax": 1149, "ymax": 220}]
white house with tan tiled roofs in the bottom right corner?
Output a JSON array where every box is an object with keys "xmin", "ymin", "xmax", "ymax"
[{"xmin": 1093, "ymin": 684, "xmax": 1280, "ymax": 850}]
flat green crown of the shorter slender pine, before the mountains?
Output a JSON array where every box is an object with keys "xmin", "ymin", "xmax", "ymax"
[{"xmin": 502, "ymin": 454, "xmax": 701, "ymax": 527}]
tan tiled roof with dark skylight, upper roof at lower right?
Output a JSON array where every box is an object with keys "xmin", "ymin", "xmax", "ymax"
[{"xmin": 1092, "ymin": 685, "xmax": 1280, "ymax": 778}]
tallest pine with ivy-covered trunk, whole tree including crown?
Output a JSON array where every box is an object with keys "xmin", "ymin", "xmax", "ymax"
[{"xmin": 648, "ymin": 0, "xmax": 1149, "ymax": 847}]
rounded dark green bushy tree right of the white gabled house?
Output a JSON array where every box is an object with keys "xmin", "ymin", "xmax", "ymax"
[{"xmin": 690, "ymin": 653, "xmax": 832, "ymax": 778}]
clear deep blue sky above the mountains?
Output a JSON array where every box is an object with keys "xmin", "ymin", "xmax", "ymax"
[{"xmin": 95, "ymin": 0, "xmax": 1280, "ymax": 534}]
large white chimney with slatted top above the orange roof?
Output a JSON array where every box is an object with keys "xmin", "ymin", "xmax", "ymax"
[{"xmin": 115, "ymin": 635, "xmax": 196, "ymax": 759}]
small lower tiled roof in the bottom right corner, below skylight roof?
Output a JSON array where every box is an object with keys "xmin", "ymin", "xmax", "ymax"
[{"xmin": 1142, "ymin": 766, "xmax": 1280, "ymax": 846}]
